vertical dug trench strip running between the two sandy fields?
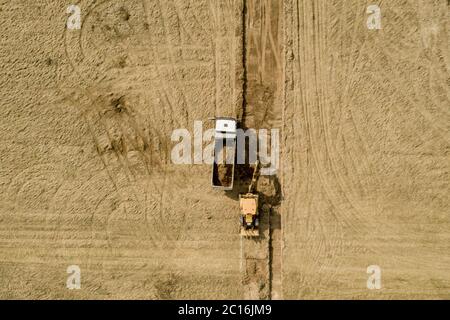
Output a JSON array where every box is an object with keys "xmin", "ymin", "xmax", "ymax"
[{"xmin": 234, "ymin": 0, "xmax": 282, "ymax": 299}]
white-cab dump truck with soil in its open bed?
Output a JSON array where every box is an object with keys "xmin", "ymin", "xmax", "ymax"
[{"xmin": 211, "ymin": 117, "xmax": 237, "ymax": 190}]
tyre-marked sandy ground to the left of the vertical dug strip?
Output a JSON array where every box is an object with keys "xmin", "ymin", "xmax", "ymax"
[{"xmin": 0, "ymin": 0, "xmax": 243, "ymax": 299}]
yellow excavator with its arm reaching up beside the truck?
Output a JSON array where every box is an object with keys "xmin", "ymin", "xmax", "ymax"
[{"xmin": 239, "ymin": 161, "xmax": 259, "ymax": 237}]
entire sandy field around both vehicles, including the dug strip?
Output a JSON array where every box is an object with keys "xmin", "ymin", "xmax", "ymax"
[{"xmin": 0, "ymin": 0, "xmax": 450, "ymax": 299}]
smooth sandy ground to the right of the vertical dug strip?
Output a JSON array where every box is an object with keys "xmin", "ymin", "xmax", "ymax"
[{"xmin": 282, "ymin": 1, "xmax": 450, "ymax": 299}]
